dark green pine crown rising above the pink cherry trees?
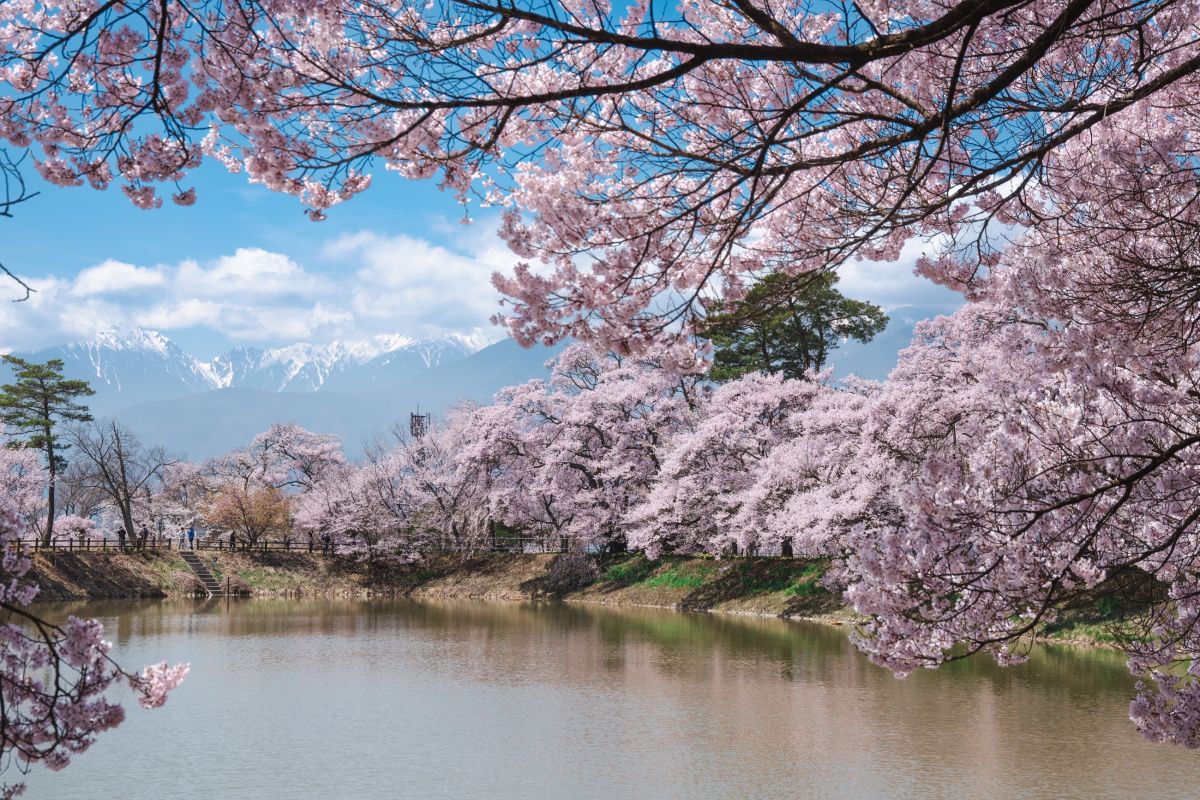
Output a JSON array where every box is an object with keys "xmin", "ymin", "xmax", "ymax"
[{"xmin": 703, "ymin": 272, "xmax": 888, "ymax": 380}]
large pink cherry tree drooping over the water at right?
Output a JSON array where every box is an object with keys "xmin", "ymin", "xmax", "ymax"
[{"xmin": 845, "ymin": 209, "xmax": 1200, "ymax": 746}]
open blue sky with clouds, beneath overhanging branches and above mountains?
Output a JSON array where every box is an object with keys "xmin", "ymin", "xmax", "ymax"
[{"xmin": 0, "ymin": 163, "xmax": 954, "ymax": 357}]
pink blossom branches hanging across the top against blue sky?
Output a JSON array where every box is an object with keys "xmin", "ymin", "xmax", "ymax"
[{"xmin": 0, "ymin": 0, "xmax": 1200, "ymax": 349}]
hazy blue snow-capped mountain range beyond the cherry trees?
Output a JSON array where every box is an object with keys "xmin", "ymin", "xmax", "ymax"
[{"xmin": 0, "ymin": 307, "xmax": 946, "ymax": 459}]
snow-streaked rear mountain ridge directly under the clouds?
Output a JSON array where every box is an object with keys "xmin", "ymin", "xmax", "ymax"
[{"xmin": 11, "ymin": 327, "xmax": 487, "ymax": 414}]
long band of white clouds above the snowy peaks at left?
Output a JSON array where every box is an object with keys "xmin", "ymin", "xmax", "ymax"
[{"xmin": 0, "ymin": 225, "xmax": 515, "ymax": 351}]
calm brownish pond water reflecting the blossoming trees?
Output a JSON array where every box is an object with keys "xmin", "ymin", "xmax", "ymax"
[{"xmin": 16, "ymin": 600, "xmax": 1200, "ymax": 800}]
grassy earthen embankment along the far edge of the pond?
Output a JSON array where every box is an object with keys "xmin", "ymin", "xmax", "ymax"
[{"xmin": 23, "ymin": 551, "xmax": 1130, "ymax": 645}]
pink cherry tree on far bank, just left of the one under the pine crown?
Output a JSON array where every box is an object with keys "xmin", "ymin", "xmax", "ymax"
[{"xmin": 485, "ymin": 344, "xmax": 702, "ymax": 549}]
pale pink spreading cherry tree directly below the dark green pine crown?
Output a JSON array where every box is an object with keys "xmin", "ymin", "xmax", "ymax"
[{"xmin": 629, "ymin": 373, "xmax": 866, "ymax": 557}]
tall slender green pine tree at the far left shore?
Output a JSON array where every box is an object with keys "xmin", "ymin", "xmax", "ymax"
[{"xmin": 0, "ymin": 355, "xmax": 96, "ymax": 545}]
